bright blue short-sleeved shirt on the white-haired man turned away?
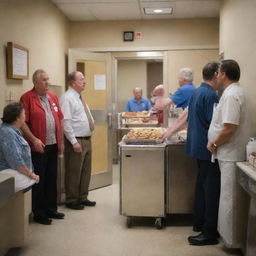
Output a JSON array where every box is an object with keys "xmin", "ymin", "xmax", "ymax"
[{"xmin": 169, "ymin": 83, "xmax": 196, "ymax": 109}]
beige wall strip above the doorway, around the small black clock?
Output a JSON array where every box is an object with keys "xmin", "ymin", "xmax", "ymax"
[{"xmin": 70, "ymin": 19, "xmax": 219, "ymax": 48}]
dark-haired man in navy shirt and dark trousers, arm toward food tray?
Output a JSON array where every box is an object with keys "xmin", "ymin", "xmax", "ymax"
[{"xmin": 164, "ymin": 62, "xmax": 220, "ymax": 245}]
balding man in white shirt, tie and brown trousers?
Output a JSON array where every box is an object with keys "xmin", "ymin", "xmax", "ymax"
[{"xmin": 60, "ymin": 71, "xmax": 96, "ymax": 210}]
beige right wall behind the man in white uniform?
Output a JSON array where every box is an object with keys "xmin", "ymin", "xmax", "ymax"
[{"xmin": 220, "ymin": 0, "xmax": 256, "ymax": 136}]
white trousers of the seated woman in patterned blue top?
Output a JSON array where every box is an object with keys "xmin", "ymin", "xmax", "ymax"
[{"xmin": 0, "ymin": 169, "xmax": 35, "ymax": 192}]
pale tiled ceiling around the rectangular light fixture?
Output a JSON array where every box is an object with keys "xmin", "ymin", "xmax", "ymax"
[{"xmin": 51, "ymin": 0, "xmax": 221, "ymax": 21}]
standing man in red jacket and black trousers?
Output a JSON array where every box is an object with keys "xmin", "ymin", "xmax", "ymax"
[{"xmin": 21, "ymin": 69, "xmax": 64, "ymax": 225}]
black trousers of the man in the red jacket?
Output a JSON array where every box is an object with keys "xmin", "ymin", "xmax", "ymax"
[{"xmin": 32, "ymin": 144, "xmax": 58, "ymax": 218}]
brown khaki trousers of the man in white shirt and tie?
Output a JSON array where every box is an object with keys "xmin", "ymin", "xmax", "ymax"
[{"xmin": 64, "ymin": 138, "xmax": 92, "ymax": 203}]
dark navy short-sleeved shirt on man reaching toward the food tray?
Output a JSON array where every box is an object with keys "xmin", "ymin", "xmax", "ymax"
[{"xmin": 187, "ymin": 83, "xmax": 219, "ymax": 160}]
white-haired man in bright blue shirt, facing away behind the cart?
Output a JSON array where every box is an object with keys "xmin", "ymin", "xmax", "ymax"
[{"xmin": 154, "ymin": 68, "xmax": 196, "ymax": 109}]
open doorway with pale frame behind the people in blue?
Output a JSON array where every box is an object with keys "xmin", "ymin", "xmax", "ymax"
[{"xmin": 111, "ymin": 51, "xmax": 168, "ymax": 163}]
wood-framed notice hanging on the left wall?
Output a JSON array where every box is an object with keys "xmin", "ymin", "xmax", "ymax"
[{"xmin": 7, "ymin": 42, "xmax": 28, "ymax": 79}]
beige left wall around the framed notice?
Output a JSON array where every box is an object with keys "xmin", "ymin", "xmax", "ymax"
[{"xmin": 0, "ymin": 0, "xmax": 69, "ymax": 113}]
